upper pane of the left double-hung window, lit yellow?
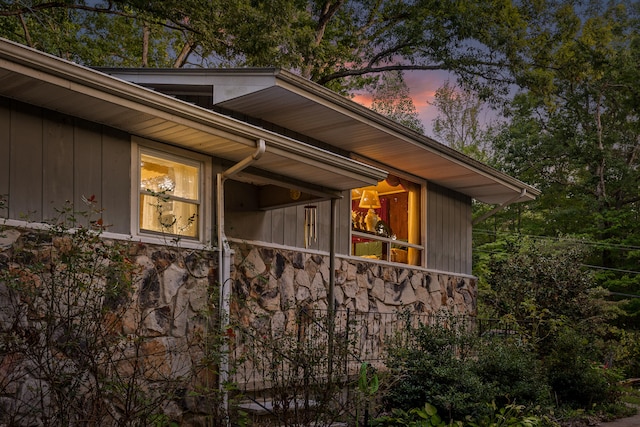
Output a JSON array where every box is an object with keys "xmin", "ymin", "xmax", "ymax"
[{"xmin": 140, "ymin": 154, "xmax": 200, "ymax": 201}]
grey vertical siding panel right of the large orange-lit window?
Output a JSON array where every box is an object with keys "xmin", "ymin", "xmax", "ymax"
[{"xmin": 426, "ymin": 183, "xmax": 472, "ymax": 274}]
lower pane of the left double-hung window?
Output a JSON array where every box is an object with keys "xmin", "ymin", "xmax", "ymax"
[{"xmin": 140, "ymin": 194, "xmax": 198, "ymax": 238}]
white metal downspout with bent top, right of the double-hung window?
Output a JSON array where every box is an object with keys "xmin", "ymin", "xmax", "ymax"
[{"xmin": 216, "ymin": 139, "xmax": 266, "ymax": 422}]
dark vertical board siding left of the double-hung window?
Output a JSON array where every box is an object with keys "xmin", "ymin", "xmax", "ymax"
[{"xmin": 0, "ymin": 97, "xmax": 131, "ymax": 234}]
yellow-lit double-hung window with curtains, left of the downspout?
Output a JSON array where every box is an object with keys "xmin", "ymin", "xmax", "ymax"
[{"xmin": 137, "ymin": 146, "xmax": 203, "ymax": 240}]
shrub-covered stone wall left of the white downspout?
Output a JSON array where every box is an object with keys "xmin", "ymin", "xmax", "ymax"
[{"xmin": 0, "ymin": 228, "xmax": 219, "ymax": 426}]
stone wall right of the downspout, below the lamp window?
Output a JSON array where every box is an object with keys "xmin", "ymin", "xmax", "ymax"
[{"xmin": 232, "ymin": 243, "xmax": 477, "ymax": 323}]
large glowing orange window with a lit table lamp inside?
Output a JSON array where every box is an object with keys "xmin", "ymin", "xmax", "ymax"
[{"xmin": 351, "ymin": 175, "xmax": 424, "ymax": 265}]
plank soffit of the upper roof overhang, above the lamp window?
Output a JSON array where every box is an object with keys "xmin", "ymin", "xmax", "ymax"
[{"xmin": 214, "ymin": 70, "xmax": 539, "ymax": 204}]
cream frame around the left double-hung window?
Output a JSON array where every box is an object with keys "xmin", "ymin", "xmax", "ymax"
[{"xmin": 131, "ymin": 136, "xmax": 213, "ymax": 244}]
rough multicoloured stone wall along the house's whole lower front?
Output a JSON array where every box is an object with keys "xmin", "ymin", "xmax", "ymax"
[{"xmin": 0, "ymin": 228, "xmax": 476, "ymax": 426}]
